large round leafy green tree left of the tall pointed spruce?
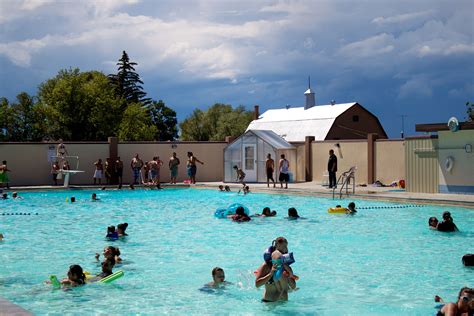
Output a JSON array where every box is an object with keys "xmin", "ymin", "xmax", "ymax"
[{"xmin": 38, "ymin": 68, "xmax": 121, "ymax": 140}]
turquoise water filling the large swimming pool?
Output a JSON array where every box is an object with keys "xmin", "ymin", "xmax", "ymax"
[{"xmin": 0, "ymin": 189, "xmax": 474, "ymax": 315}]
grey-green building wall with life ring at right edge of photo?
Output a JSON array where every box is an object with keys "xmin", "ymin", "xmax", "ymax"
[{"xmin": 438, "ymin": 130, "xmax": 474, "ymax": 194}]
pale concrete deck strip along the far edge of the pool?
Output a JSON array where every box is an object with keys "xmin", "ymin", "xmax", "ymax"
[{"xmin": 6, "ymin": 182, "xmax": 474, "ymax": 209}]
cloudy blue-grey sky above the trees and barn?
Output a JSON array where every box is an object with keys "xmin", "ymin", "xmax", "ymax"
[{"xmin": 0, "ymin": 0, "xmax": 474, "ymax": 137}]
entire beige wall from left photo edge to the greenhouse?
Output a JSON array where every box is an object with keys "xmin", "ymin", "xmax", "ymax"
[{"xmin": 0, "ymin": 142, "xmax": 227, "ymax": 186}]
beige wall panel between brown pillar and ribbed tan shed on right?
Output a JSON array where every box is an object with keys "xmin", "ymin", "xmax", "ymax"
[{"xmin": 375, "ymin": 139, "xmax": 406, "ymax": 184}]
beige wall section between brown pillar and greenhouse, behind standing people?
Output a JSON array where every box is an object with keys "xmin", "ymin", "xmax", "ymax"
[{"xmin": 118, "ymin": 142, "xmax": 227, "ymax": 183}]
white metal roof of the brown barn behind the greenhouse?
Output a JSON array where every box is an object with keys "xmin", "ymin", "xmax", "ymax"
[{"xmin": 247, "ymin": 102, "xmax": 357, "ymax": 142}]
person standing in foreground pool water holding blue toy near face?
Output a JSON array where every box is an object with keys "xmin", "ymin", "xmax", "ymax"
[{"xmin": 255, "ymin": 237, "xmax": 296, "ymax": 302}]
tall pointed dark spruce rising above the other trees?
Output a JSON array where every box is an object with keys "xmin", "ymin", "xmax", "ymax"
[{"xmin": 109, "ymin": 51, "xmax": 151, "ymax": 110}]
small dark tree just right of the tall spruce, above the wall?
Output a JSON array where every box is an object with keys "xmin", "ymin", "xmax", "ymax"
[{"xmin": 148, "ymin": 100, "xmax": 178, "ymax": 141}]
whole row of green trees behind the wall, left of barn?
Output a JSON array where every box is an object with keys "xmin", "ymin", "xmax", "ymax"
[{"xmin": 0, "ymin": 51, "xmax": 252, "ymax": 141}]
